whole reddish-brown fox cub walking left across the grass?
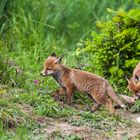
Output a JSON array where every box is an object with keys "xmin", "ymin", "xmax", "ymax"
[{"xmin": 41, "ymin": 53, "xmax": 124, "ymax": 113}]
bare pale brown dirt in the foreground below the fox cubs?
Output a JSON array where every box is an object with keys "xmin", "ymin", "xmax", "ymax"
[{"xmin": 36, "ymin": 106, "xmax": 140, "ymax": 140}]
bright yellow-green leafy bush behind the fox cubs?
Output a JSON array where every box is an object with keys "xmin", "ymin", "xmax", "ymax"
[{"xmin": 84, "ymin": 9, "xmax": 140, "ymax": 91}]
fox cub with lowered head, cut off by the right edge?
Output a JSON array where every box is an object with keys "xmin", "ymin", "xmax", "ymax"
[{"xmin": 127, "ymin": 62, "xmax": 140, "ymax": 98}]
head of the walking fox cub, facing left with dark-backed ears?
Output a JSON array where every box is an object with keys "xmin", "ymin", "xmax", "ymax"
[{"xmin": 41, "ymin": 53, "xmax": 62, "ymax": 76}]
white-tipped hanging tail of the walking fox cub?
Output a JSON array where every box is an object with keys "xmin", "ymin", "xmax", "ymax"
[{"xmin": 106, "ymin": 82, "xmax": 125, "ymax": 108}]
